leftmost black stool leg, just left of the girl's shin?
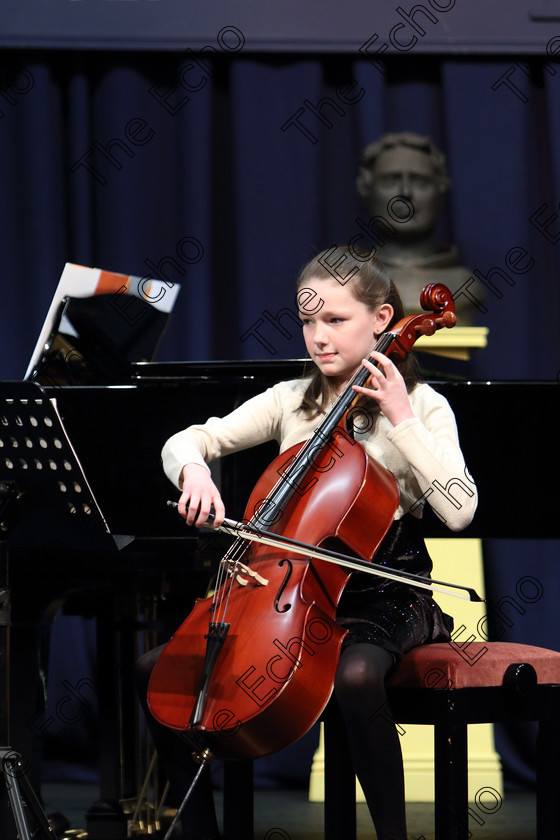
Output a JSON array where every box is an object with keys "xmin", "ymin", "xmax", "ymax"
[{"xmin": 324, "ymin": 702, "xmax": 356, "ymax": 840}]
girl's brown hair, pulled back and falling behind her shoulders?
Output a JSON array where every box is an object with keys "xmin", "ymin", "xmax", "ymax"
[{"xmin": 297, "ymin": 246, "xmax": 420, "ymax": 417}]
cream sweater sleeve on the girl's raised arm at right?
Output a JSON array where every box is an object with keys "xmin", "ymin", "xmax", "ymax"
[{"xmin": 387, "ymin": 386, "xmax": 478, "ymax": 531}]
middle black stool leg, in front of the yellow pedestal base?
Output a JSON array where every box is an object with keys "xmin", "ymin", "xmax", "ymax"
[{"xmin": 434, "ymin": 709, "xmax": 470, "ymax": 840}]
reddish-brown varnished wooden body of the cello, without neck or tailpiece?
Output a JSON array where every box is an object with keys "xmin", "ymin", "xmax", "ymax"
[{"xmin": 144, "ymin": 430, "xmax": 399, "ymax": 758}]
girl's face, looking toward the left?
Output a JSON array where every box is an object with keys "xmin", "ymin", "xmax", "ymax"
[{"xmin": 297, "ymin": 278, "xmax": 393, "ymax": 390}]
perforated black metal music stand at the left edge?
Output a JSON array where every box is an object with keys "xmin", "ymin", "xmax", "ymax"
[{"xmin": 0, "ymin": 382, "xmax": 132, "ymax": 840}]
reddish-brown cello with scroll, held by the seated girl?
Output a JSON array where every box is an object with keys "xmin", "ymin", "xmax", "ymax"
[{"xmin": 148, "ymin": 284, "xmax": 478, "ymax": 759}]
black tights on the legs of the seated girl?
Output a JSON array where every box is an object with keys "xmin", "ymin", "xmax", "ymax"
[{"xmin": 136, "ymin": 644, "xmax": 406, "ymax": 840}]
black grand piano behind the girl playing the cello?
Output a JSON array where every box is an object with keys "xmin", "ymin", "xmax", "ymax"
[{"xmin": 0, "ymin": 344, "xmax": 558, "ymax": 840}]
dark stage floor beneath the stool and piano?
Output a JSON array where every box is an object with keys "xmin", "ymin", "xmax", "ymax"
[{"xmin": 43, "ymin": 783, "xmax": 540, "ymax": 840}]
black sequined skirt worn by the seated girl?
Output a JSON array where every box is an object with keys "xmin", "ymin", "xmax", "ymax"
[{"xmin": 336, "ymin": 516, "xmax": 453, "ymax": 662}]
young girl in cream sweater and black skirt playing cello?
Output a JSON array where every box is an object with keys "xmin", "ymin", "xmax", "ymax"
[{"xmin": 143, "ymin": 247, "xmax": 476, "ymax": 840}]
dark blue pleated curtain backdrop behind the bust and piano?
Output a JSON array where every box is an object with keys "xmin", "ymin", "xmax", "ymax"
[{"xmin": 0, "ymin": 50, "xmax": 560, "ymax": 785}]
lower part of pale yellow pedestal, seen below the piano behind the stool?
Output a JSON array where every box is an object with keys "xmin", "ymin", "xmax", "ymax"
[{"xmin": 309, "ymin": 538, "xmax": 503, "ymax": 802}]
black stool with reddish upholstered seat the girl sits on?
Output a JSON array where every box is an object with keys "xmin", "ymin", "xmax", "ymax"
[{"xmin": 324, "ymin": 642, "xmax": 560, "ymax": 840}]
